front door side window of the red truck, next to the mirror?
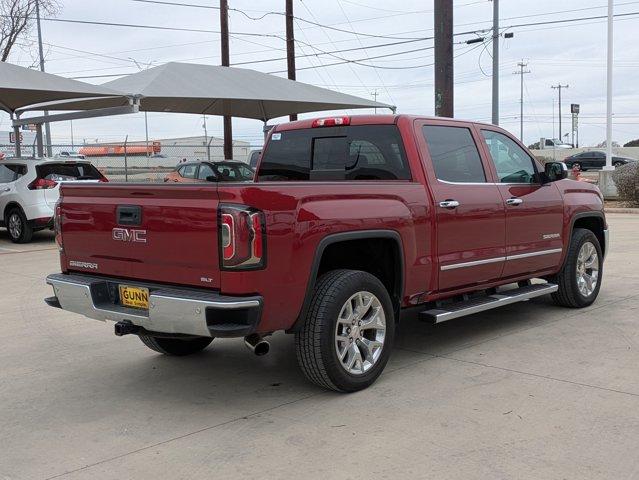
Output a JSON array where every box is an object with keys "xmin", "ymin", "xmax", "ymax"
[{"xmin": 481, "ymin": 130, "xmax": 537, "ymax": 183}]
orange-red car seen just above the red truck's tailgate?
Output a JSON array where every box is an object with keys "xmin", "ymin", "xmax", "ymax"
[{"xmin": 164, "ymin": 160, "xmax": 255, "ymax": 183}]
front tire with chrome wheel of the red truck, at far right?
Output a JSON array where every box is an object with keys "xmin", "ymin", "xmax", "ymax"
[{"xmin": 552, "ymin": 228, "xmax": 603, "ymax": 308}]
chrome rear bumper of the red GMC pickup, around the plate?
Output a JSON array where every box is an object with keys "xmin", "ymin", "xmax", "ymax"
[{"xmin": 47, "ymin": 274, "xmax": 262, "ymax": 337}]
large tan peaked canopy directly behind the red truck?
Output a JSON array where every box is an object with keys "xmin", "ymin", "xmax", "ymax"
[{"xmin": 25, "ymin": 62, "xmax": 394, "ymax": 121}]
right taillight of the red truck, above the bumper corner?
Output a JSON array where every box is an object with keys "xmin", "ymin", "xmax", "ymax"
[{"xmin": 219, "ymin": 205, "xmax": 266, "ymax": 270}]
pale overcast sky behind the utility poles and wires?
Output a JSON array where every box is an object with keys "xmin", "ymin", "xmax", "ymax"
[{"xmin": 0, "ymin": 0, "xmax": 639, "ymax": 146}]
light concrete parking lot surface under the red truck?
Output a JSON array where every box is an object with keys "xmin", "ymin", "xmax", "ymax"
[{"xmin": 0, "ymin": 214, "xmax": 639, "ymax": 480}]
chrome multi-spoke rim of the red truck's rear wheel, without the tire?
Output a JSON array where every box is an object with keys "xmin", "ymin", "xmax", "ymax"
[{"xmin": 335, "ymin": 291, "xmax": 386, "ymax": 375}]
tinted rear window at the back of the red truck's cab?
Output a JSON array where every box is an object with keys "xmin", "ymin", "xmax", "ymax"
[{"xmin": 258, "ymin": 125, "xmax": 411, "ymax": 181}]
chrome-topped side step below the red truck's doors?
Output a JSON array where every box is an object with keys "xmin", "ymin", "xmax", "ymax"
[{"xmin": 419, "ymin": 283, "xmax": 559, "ymax": 323}]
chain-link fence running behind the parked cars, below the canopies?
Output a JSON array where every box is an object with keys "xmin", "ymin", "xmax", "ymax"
[{"xmin": 0, "ymin": 142, "xmax": 262, "ymax": 182}]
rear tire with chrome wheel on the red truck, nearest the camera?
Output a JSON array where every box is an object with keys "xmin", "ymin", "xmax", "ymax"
[{"xmin": 295, "ymin": 270, "xmax": 395, "ymax": 392}]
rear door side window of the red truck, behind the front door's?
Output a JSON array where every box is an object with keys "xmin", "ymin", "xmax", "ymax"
[{"xmin": 422, "ymin": 125, "xmax": 486, "ymax": 183}]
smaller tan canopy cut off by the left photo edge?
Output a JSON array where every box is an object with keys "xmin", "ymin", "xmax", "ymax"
[{"xmin": 0, "ymin": 62, "xmax": 124, "ymax": 113}]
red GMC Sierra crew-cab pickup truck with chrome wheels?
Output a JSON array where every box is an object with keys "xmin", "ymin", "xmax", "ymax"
[{"xmin": 46, "ymin": 115, "xmax": 608, "ymax": 391}]
